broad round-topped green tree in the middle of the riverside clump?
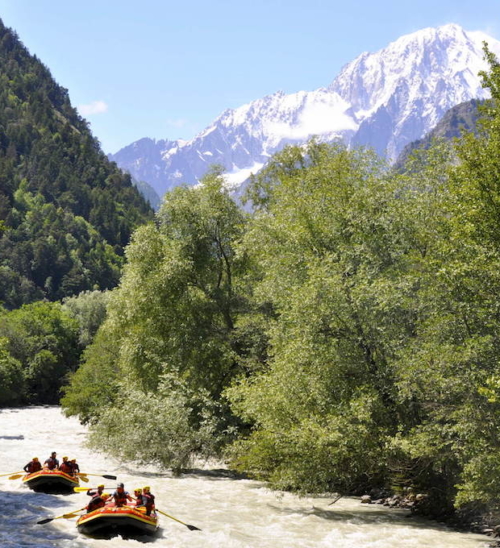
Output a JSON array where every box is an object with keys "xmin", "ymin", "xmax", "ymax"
[{"xmin": 227, "ymin": 142, "xmax": 411, "ymax": 492}]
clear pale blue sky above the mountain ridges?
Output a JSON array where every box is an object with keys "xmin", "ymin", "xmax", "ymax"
[{"xmin": 0, "ymin": 0, "xmax": 500, "ymax": 152}]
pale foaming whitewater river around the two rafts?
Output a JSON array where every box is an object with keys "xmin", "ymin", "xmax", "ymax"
[{"xmin": 0, "ymin": 407, "xmax": 489, "ymax": 548}]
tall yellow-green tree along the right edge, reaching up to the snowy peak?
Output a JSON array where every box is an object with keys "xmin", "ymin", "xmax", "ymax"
[{"xmin": 406, "ymin": 47, "xmax": 500, "ymax": 507}]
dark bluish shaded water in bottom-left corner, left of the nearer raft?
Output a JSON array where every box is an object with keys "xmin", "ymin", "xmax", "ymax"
[{"xmin": 0, "ymin": 491, "xmax": 74, "ymax": 548}]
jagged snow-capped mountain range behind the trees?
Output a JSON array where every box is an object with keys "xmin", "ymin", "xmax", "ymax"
[{"xmin": 111, "ymin": 24, "xmax": 500, "ymax": 196}]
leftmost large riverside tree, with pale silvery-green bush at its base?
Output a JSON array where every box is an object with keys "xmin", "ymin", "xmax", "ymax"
[{"xmin": 63, "ymin": 171, "xmax": 252, "ymax": 468}]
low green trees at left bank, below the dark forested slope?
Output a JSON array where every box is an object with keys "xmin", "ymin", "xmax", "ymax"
[{"xmin": 0, "ymin": 291, "xmax": 108, "ymax": 406}]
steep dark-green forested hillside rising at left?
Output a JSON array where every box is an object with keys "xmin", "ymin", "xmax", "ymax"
[{"xmin": 0, "ymin": 21, "xmax": 152, "ymax": 309}]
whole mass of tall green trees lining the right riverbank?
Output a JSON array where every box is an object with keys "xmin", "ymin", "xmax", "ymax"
[{"xmin": 62, "ymin": 45, "xmax": 500, "ymax": 510}]
